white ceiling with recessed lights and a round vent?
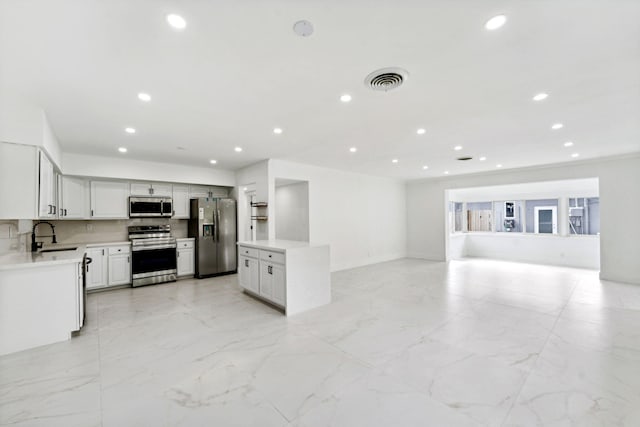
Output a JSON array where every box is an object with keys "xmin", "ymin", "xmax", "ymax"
[{"xmin": 0, "ymin": 0, "xmax": 640, "ymax": 178}]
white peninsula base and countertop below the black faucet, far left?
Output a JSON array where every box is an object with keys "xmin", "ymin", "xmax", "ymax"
[{"xmin": 0, "ymin": 246, "xmax": 85, "ymax": 355}]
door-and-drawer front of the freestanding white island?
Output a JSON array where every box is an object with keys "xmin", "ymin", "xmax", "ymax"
[{"xmin": 238, "ymin": 246, "xmax": 287, "ymax": 307}]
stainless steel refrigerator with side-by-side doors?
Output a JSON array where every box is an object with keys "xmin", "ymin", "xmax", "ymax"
[{"xmin": 189, "ymin": 198, "xmax": 237, "ymax": 279}]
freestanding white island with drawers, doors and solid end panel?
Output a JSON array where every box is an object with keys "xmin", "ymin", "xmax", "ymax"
[{"xmin": 238, "ymin": 240, "xmax": 331, "ymax": 315}]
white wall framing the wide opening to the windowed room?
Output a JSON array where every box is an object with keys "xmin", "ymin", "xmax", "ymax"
[{"xmin": 407, "ymin": 154, "xmax": 640, "ymax": 284}]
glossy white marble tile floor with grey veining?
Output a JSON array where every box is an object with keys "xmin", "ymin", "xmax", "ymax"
[{"xmin": 0, "ymin": 259, "xmax": 640, "ymax": 427}]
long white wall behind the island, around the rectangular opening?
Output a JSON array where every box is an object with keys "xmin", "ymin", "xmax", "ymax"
[{"xmin": 270, "ymin": 160, "xmax": 407, "ymax": 271}]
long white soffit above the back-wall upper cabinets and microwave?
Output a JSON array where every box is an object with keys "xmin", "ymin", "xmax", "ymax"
[{"xmin": 62, "ymin": 153, "xmax": 235, "ymax": 187}]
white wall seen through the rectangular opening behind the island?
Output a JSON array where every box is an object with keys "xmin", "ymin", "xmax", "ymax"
[{"xmin": 275, "ymin": 182, "xmax": 309, "ymax": 242}]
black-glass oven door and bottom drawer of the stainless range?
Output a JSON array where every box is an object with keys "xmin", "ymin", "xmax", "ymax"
[{"xmin": 131, "ymin": 246, "xmax": 178, "ymax": 286}]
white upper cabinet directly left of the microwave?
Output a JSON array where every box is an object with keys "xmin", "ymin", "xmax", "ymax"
[{"xmin": 91, "ymin": 181, "xmax": 129, "ymax": 219}]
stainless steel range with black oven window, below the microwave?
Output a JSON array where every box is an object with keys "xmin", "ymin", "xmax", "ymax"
[{"xmin": 129, "ymin": 224, "xmax": 178, "ymax": 286}]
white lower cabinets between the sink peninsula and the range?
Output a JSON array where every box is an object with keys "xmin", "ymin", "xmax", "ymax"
[{"xmin": 87, "ymin": 245, "xmax": 131, "ymax": 290}]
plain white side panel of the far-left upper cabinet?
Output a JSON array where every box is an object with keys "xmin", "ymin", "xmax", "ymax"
[{"xmin": 0, "ymin": 142, "xmax": 39, "ymax": 219}]
